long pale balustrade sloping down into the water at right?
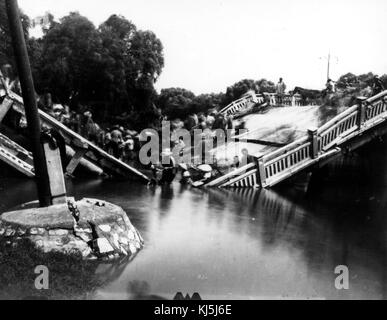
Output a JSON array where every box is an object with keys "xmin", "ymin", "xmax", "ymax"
[{"xmin": 212, "ymin": 91, "xmax": 387, "ymax": 187}]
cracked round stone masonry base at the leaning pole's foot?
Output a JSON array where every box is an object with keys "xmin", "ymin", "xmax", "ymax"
[{"xmin": 0, "ymin": 199, "xmax": 143, "ymax": 260}]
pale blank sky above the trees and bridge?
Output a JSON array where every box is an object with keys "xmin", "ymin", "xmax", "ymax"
[{"xmin": 18, "ymin": 0, "xmax": 387, "ymax": 94}]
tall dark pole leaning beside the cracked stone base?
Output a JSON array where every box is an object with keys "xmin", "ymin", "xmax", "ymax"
[{"xmin": 6, "ymin": 0, "xmax": 51, "ymax": 207}]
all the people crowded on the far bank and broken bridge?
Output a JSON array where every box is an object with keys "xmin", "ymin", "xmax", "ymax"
[{"xmin": 32, "ymin": 77, "xmax": 384, "ymax": 184}]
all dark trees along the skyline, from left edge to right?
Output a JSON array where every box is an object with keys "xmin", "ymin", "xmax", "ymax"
[{"xmin": 0, "ymin": 0, "xmax": 387, "ymax": 130}]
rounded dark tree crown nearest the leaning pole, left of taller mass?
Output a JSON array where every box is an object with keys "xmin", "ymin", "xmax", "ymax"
[{"xmin": 36, "ymin": 12, "xmax": 102, "ymax": 103}]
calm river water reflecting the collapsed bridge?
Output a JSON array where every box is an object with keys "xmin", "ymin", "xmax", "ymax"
[{"xmin": 0, "ymin": 138, "xmax": 387, "ymax": 299}]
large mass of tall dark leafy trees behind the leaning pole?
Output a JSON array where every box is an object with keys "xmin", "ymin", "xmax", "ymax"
[{"xmin": 0, "ymin": 5, "xmax": 164, "ymax": 126}]
